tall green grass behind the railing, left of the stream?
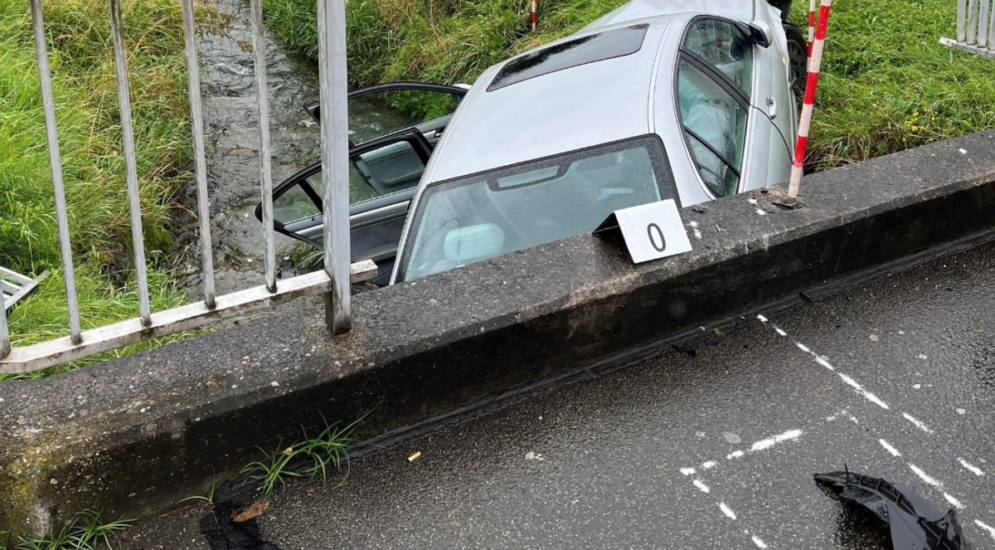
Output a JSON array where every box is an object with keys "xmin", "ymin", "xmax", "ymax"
[{"xmin": 0, "ymin": 0, "xmax": 198, "ymax": 380}]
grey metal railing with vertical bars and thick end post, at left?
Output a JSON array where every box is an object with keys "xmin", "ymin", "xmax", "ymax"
[{"xmin": 0, "ymin": 0, "xmax": 377, "ymax": 374}]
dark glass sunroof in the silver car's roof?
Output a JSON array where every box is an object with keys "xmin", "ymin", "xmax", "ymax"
[{"xmin": 487, "ymin": 24, "xmax": 649, "ymax": 92}]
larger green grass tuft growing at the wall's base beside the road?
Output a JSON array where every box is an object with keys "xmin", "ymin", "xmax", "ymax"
[{"xmin": 242, "ymin": 415, "xmax": 365, "ymax": 498}]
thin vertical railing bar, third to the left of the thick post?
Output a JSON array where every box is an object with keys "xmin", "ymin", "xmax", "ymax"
[{"xmin": 111, "ymin": 0, "xmax": 152, "ymax": 326}]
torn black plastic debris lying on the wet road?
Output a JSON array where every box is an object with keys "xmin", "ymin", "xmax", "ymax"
[{"xmin": 815, "ymin": 471, "xmax": 971, "ymax": 550}]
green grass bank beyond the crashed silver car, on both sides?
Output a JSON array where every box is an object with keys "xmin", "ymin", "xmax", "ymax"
[{"xmin": 264, "ymin": 0, "xmax": 995, "ymax": 170}]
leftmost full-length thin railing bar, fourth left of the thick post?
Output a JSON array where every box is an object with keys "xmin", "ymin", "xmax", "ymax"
[{"xmin": 31, "ymin": 0, "xmax": 83, "ymax": 345}]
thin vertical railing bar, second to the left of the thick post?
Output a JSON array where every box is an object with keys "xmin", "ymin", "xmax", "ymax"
[{"xmin": 183, "ymin": 0, "xmax": 217, "ymax": 309}]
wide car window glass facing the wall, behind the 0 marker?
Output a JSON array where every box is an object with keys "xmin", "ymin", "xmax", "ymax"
[{"xmin": 398, "ymin": 136, "xmax": 675, "ymax": 281}]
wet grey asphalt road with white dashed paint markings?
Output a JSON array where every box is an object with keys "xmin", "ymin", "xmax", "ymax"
[{"xmin": 126, "ymin": 244, "xmax": 995, "ymax": 550}]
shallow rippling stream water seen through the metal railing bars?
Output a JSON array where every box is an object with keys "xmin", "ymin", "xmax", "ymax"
[{"xmin": 177, "ymin": 0, "xmax": 321, "ymax": 294}]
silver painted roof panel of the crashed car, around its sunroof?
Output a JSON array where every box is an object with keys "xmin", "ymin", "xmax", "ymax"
[{"xmin": 422, "ymin": 17, "xmax": 671, "ymax": 185}]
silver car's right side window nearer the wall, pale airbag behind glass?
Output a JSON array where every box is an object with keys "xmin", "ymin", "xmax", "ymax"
[{"xmin": 677, "ymin": 59, "xmax": 748, "ymax": 197}]
